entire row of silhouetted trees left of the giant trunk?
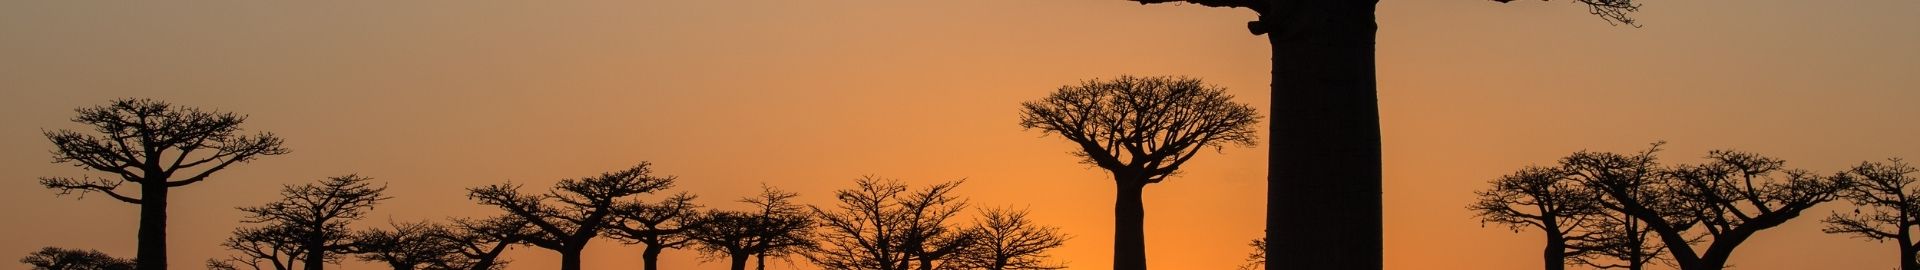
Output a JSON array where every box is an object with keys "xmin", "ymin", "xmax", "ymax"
[{"xmin": 23, "ymin": 77, "xmax": 1261, "ymax": 270}]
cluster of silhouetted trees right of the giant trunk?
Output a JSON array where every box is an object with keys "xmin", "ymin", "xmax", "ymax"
[{"xmin": 1467, "ymin": 144, "xmax": 1920, "ymax": 270}]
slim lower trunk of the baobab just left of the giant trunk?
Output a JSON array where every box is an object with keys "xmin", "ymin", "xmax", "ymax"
[{"xmin": 1114, "ymin": 179, "xmax": 1146, "ymax": 270}]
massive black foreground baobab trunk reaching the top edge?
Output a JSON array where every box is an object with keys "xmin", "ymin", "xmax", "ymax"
[{"xmin": 1250, "ymin": 0, "xmax": 1382, "ymax": 270}]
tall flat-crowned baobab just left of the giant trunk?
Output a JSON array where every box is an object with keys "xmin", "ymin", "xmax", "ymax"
[{"xmin": 1020, "ymin": 77, "xmax": 1260, "ymax": 270}]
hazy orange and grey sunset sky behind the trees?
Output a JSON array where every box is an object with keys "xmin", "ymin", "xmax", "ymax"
[{"xmin": 0, "ymin": 0, "xmax": 1920, "ymax": 270}]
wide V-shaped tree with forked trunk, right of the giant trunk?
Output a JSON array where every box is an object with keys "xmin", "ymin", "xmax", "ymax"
[{"xmin": 1561, "ymin": 144, "xmax": 1849, "ymax": 270}]
